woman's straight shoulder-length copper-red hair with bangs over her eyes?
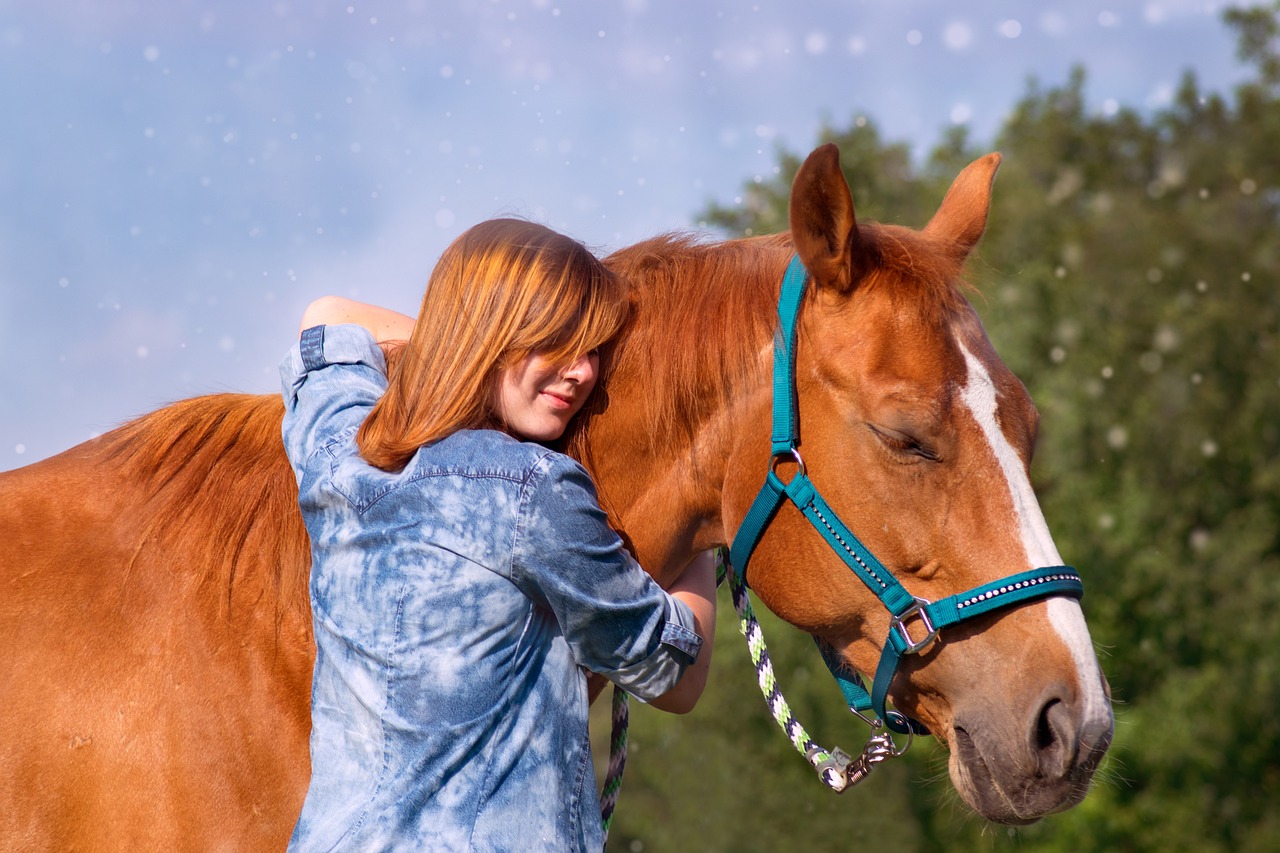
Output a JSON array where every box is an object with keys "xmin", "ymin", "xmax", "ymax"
[{"xmin": 357, "ymin": 219, "xmax": 628, "ymax": 471}]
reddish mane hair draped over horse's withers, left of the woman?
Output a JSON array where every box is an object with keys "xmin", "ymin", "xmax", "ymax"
[{"xmin": 96, "ymin": 394, "xmax": 310, "ymax": 624}]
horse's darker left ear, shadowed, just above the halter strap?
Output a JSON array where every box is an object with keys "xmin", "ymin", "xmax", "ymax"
[{"xmin": 791, "ymin": 142, "xmax": 858, "ymax": 292}]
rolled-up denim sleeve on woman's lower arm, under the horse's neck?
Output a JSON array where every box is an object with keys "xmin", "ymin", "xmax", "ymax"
[{"xmin": 512, "ymin": 453, "xmax": 703, "ymax": 702}]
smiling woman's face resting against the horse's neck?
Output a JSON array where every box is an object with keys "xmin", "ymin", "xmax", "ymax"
[{"xmin": 497, "ymin": 350, "xmax": 600, "ymax": 442}]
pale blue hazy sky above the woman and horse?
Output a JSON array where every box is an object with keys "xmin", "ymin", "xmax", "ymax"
[{"xmin": 0, "ymin": 0, "xmax": 1245, "ymax": 470}]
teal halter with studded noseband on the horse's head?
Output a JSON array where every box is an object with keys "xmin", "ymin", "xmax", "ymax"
[{"xmin": 730, "ymin": 256, "xmax": 1084, "ymax": 734}]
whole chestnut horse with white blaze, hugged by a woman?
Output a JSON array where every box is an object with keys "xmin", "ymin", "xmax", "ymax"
[{"xmin": 0, "ymin": 146, "xmax": 1112, "ymax": 850}]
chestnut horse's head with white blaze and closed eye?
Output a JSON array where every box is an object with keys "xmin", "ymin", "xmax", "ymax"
[{"xmin": 722, "ymin": 145, "xmax": 1112, "ymax": 824}]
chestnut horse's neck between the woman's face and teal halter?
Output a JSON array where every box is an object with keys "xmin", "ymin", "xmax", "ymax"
[{"xmin": 570, "ymin": 236, "xmax": 792, "ymax": 580}]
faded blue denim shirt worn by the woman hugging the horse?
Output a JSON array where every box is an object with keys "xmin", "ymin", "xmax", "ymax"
[{"xmin": 280, "ymin": 325, "xmax": 701, "ymax": 850}]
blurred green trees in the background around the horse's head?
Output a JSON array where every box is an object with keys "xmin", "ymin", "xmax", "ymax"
[{"xmin": 611, "ymin": 4, "xmax": 1280, "ymax": 850}]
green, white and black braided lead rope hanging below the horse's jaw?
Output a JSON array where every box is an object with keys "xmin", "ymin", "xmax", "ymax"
[{"xmin": 716, "ymin": 548, "xmax": 910, "ymax": 793}]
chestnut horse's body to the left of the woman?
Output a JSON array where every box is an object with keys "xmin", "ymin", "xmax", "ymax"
[{"xmin": 0, "ymin": 394, "xmax": 314, "ymax": 849}]
